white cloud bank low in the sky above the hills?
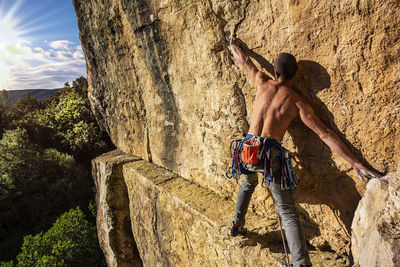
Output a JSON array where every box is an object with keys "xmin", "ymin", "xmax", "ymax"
[{"xmin": 0, "ymin": 40, "xmax": 86, "ymax": 89}]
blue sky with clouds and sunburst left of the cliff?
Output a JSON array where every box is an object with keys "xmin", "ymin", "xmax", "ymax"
[{"xmin": 0, "ymin": 0, "xmax": 86, "ymax": 90}]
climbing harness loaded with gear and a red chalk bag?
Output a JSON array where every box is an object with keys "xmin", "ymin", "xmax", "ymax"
[{"xmin": 225, "ymin": 134, "xmax": 300, "ymax": 192}]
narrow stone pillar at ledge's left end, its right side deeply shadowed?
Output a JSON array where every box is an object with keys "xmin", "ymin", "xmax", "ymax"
[{"xmin": 92, "ymin": 150, "xmax": 143, "ymax": 266}]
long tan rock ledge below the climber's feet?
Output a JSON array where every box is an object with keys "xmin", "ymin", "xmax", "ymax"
[{"xmin": 93, "ymin": 151, "xmax": 349, "ymax": 267}]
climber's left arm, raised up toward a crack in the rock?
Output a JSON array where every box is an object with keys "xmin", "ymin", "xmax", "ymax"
[{"xmin": 228, "ymin": 37, "xmax": 269, "ymax": 84}]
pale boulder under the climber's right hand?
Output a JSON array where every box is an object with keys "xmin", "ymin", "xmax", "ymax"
[{"xmin": 351, "ymin": 166, "xmax": 400, "ymax": 267}]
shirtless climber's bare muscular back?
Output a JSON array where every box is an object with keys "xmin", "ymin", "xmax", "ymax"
[{"xmin": 249, "ymin": 76, "xmax": 300, "ymax": 141}]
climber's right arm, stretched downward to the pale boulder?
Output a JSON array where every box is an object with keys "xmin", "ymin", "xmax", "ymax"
[{"xmin": 296, "ymin": 100, "xmax": 380, "ymax": 181}]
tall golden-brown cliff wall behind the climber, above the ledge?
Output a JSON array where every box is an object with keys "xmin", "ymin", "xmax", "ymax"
[{"xmin": 73, "ymin": 0, "xmax": 400, "ymax": 264}]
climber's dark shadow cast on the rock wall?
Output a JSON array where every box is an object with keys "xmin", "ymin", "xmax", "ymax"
[{"xmin": 288, "ymin": 60, "xmax": 374, "ymax": 235}]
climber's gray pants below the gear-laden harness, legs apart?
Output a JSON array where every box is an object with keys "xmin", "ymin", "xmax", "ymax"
[{"xmin": 232, "ymin": 161, "xmax": 311, "ymax": 266}]
